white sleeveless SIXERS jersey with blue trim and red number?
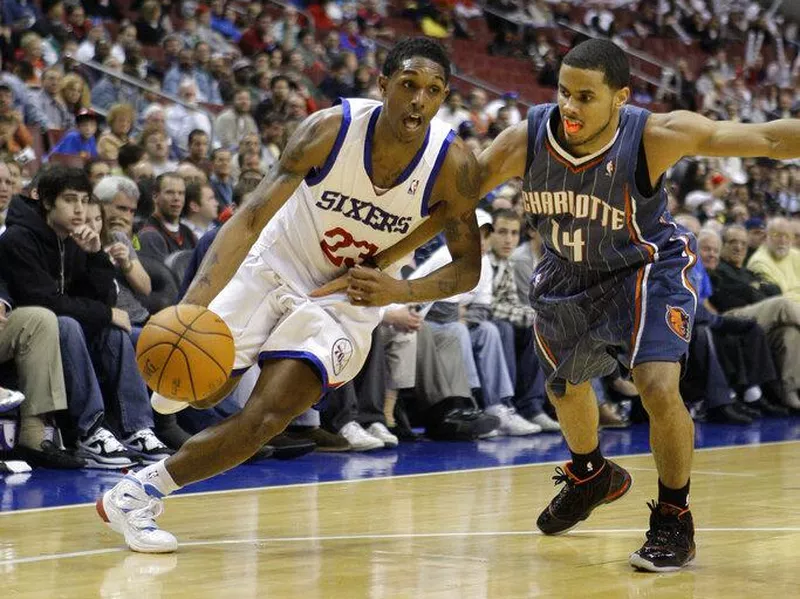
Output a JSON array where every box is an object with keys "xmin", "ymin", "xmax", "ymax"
[{"xmin": 250, "ymin": 99, "xmax": 455, "ymax": 292}]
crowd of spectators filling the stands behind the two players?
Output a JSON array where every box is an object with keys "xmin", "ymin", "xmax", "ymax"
[{"xmin": 0, "ymin": 0, "xmax": 800, "ymax": 476}]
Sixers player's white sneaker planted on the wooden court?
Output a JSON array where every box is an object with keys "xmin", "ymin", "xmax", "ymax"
[{"xmin": 95, "ymin": 474, "xmax": 178, "ymax": 553}]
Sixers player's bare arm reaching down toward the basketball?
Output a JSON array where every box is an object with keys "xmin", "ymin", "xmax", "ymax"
[{"xmin": 182, "ymin": 108, "xmax": 342, "ymax": 306}]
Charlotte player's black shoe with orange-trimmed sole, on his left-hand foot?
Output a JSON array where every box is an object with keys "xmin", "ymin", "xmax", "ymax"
[{"xmin": 536, "ymin": 460, "xmax": 631, "ymax": 535}]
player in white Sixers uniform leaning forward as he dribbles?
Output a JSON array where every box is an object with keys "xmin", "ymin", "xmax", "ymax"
[{"xmin": 97, "ymin": 38, "xmax": 481, "ymax": 553}]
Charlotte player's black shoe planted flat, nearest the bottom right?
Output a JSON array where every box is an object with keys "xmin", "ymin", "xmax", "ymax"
[{"xmin": 630, "ymin": 501, "xmax": 695, "ymax": 572}]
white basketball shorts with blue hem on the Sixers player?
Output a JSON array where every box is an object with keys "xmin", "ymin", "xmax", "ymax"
[{"xmin": 208, "ymin": 255, "xmax": 381, "ymax": 393}]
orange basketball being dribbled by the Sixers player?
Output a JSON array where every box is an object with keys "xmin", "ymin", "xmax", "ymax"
[{"xmin": 136, "ymin": 304, "xmax": 234, "ymax": 403}]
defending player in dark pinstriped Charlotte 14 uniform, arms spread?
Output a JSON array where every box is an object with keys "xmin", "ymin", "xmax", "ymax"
[{"xmin": 479, "ymin": 39, "xmax": 800, "ymax": 572}]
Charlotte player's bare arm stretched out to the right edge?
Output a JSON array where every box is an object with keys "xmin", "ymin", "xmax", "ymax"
[{"xmin": 644, "ymin": 110, "xmax": 800, "ymax": 182}]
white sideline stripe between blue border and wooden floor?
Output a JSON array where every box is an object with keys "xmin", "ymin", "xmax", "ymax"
[{"xmin": 0, "ymin": 440, "xmax": 800, "ymax": 517}]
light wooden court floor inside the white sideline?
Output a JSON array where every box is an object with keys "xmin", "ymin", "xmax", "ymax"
[{"xmin": 0, "ymin": 442, "xmax": 800, "ymax": 599}]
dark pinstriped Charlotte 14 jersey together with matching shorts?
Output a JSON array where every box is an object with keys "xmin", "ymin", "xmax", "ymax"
[{"xmin": 523, "ymin": 104, "xmax": 697, "ymax": 393}]
